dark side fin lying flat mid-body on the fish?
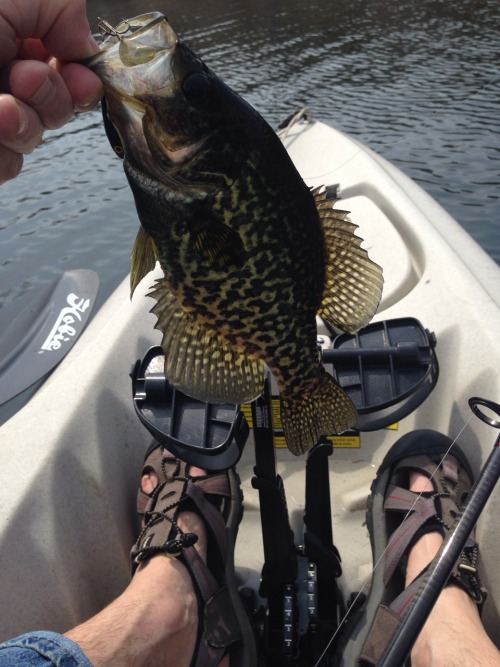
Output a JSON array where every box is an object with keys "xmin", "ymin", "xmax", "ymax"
[{"xmin": 191, "ymin": 221, "xmax": 246, "ymax": 271}]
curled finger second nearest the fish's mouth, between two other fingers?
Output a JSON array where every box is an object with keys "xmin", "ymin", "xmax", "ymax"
[{"xmin": 8, "ymin": 60, "xmax": 73, "ymax": 129}]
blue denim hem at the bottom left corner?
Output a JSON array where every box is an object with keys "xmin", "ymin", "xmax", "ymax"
[{"xmin": 0, "ymin": 631, "xmax": 92, "ymax": 667}]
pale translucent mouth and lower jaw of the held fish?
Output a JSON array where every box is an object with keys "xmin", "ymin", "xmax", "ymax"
[{"xmin": 85, "ymin": 12, "xmax": 224, "ymax": 187}]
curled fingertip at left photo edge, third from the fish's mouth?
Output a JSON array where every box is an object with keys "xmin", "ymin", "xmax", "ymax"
[{"xmin": 0, "ymin": 95, "xmax": 44, "ymax": 153}]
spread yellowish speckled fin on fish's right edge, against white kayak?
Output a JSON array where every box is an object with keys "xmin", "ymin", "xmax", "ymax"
[{"xmin": 313, "ymin": 188, "xmax": 384, "ymax": 333}]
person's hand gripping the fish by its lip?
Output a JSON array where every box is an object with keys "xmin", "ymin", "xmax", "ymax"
[{"xmin": 0, "ymin": 0, "xmax": 102, "ymax": 183}]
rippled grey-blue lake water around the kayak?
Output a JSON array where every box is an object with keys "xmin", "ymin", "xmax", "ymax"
[{"xmin": 0, "ymin": 0, "xmax": 500, "ymax": 333}]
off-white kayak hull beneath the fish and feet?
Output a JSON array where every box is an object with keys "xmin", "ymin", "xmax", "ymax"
[{"xmin": 0, "ymin": 114, "xmax": 500, "ymax": 656}]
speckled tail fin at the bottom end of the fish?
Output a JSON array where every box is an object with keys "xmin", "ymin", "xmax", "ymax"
[{"xmin": 281, "ymin": 368, "xmax": 358, "ymax": 456}]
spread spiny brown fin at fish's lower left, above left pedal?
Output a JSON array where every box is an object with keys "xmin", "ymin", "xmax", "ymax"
[{"xmin": 149, "ymin": 278, "xmax": 264, "ymax": 404}]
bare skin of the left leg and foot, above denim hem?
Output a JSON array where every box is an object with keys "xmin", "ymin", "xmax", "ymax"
[{"xmin": 66, "ymin": 469, "xmax": 229, "ymax": 667}]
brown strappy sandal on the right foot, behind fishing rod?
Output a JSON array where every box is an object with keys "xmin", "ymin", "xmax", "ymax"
[{"xmin": 338, "ymin": 430, "xmax": 486, "ymax": 667}]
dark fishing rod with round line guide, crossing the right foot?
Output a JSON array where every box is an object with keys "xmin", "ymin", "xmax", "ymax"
[{"xmin": 377, "ymin": 397, "xmax": 500, "ymax": 667}]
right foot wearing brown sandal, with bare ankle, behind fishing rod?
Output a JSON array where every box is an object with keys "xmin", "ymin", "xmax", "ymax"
[{"xmin": 346, "ymin": 430, "xmax": 499, "ymax": 667}]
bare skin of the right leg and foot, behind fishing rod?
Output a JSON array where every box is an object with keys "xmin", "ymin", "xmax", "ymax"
[{"xmin": 406, "ymin": 472, "xmax": 500, "ymax": 667}]
